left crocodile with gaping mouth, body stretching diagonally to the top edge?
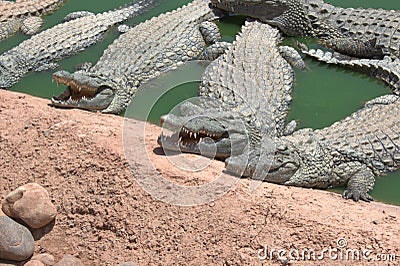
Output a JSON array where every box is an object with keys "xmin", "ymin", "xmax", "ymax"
[{"xmin": 51, "ymin": 0, "xmax": 229, "ymax": 114}]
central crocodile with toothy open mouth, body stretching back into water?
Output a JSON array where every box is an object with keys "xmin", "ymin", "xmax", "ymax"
[{"xmin": 158, "ymin": 21, "xmax": 295, "ymax": 165}]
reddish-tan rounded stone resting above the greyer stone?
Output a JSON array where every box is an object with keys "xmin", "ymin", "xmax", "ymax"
[{"xmin": 2, "ymin": 183, "xmax": 57, "ymax": 229}]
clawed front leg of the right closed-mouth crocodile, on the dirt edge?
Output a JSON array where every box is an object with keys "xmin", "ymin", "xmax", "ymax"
[{"xmin": 338, "ymin": 162, "xmax": 375, "ymax": 202}]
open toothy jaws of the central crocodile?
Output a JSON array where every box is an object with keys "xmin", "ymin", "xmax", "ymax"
[{"xmin": 157, "ymin": 115, "xmax": 231, "ymax": 160}]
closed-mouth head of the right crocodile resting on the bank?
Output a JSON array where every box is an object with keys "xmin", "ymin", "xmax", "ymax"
[{"xmin": 225, "ymin": 132, "xmax": 336, "ymax": 188}]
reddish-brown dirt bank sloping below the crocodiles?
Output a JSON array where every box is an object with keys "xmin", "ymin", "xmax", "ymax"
[{"xmin": 0, "ymin": 90, "xmax": 400, "ymax": 265}]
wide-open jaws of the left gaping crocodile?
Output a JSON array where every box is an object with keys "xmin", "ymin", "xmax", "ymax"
[{"xmin": 51, "ymin": 71, "xmax": 115, "ymax": 111}]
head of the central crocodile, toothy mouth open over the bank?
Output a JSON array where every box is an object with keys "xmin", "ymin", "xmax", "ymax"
[{"xmin": 158, "ymin": 103, "xmax": 249, "ymax": 160}]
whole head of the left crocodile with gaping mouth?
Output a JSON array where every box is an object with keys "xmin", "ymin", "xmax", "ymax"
[{"xmin": 51, "ymin": 70, "xmax": 119, "ymax": 111}]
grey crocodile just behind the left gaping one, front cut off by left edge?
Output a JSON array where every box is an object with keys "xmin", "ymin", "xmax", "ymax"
[{"xmin": 0, "ymin": 0, "xmax": 157, "ymax": 89}]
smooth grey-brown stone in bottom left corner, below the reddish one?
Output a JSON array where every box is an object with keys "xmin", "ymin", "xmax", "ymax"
[{"xmin": 0, "ymin": 216, "xmax": 35, "ymax": 261}]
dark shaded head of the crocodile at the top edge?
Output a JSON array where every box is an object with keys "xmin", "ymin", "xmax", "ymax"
[{"xmin": 211, "ymin": 0, "xmax": 290, "ymax": 21}]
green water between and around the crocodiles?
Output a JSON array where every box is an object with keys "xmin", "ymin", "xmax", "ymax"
[{"xmin": 0, "ymin": 0, "xmax": 400, "ymax": 205}]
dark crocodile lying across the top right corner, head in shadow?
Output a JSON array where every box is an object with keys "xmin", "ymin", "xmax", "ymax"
[{"xmin": 212, "ymin": 0, "xmax": 400, "ymax": 58}]
